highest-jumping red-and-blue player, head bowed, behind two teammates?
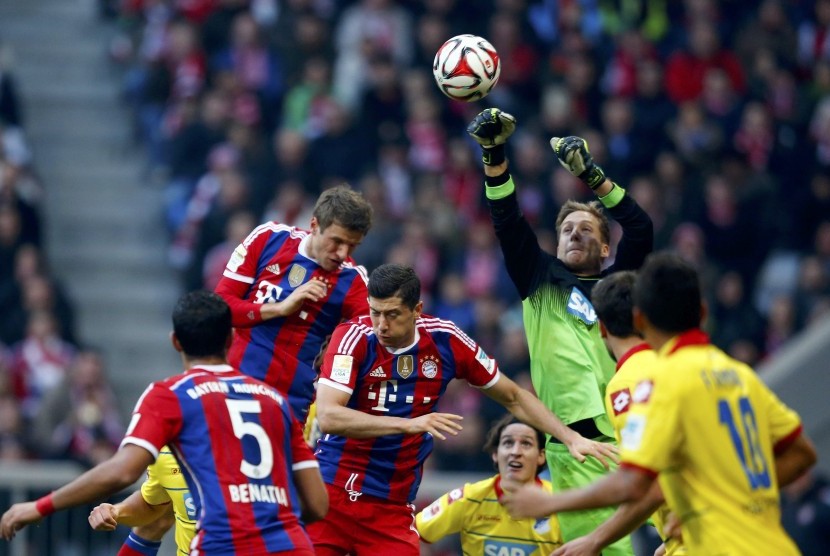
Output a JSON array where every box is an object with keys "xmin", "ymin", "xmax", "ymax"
[{"xmin": 216, "ymin": 186, "xmax": 372, "ymax": 423}]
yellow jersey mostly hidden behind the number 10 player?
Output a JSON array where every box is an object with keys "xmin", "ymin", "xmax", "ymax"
[{"xmin": 605, "ymin": 343, "xmax": 687, "ymax": 556}]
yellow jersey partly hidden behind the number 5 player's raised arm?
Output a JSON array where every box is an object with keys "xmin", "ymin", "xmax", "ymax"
[{"xmin": 141, "ymin": 446, "xmax": 196, "ymax": 556}]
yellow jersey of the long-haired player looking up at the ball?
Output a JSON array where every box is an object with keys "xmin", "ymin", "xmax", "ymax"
[{"xmin": 415, "ymin": 475, "xmax": 562, "ymax": 556}]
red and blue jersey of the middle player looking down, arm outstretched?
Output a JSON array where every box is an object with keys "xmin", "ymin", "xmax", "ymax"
[{"xmin": 315, "ymin": 315, "xmax": 500, "ymax": 502}]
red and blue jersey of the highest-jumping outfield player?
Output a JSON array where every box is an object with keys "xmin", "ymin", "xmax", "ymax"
[{"xmin": 216, "ymin": 222, "xmax": 369, "ymax": 423}]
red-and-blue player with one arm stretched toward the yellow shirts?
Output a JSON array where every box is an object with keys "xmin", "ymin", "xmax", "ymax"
[{"xmin": 308, "ymin": 264, "xmax": 612, "ymax": 556}]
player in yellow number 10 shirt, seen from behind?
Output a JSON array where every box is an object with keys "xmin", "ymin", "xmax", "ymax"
[{"xmin": 504, "ymin": 253, "xmax": 816, "ymax": 556}]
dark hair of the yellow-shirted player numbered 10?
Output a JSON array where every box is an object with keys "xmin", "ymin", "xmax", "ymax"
[{"xmin": 634, "ymin": 251, "xmax": 702, "ymax": 334}]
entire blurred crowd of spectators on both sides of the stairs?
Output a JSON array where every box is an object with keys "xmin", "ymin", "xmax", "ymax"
[{"xmin": 0, "ymin": 0, "xmax": 830, "ymax": 500}]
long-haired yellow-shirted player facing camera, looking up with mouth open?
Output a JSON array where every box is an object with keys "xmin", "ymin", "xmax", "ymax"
[{"xmin": 415, "ymin": 415, "xmax": 562, "ymax": 556}]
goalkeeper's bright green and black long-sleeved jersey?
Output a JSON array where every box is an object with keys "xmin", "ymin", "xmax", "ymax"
[{"xmin": 487, "ymin": 175, "xmax": 653, "ymax": 438}]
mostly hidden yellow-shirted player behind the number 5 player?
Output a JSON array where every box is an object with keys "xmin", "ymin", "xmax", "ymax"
[{"xmin": 89, "ymin": 447, "xmax": 196, "ymax": 556}]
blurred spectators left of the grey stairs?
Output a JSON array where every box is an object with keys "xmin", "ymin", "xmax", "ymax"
[{"xmin": 0, "ymin": 45, "xmax": 124, "ymax": 466}]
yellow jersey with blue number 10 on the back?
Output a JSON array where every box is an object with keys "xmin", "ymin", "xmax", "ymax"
[{"xmin": 621, "ymin": 330, "xmax": 801, "ymax": 556}]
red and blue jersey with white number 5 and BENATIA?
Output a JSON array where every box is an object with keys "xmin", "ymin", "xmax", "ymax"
[{"xmin": 122, "ymin": 365, "xmax": 317, "ymax": 556}]
